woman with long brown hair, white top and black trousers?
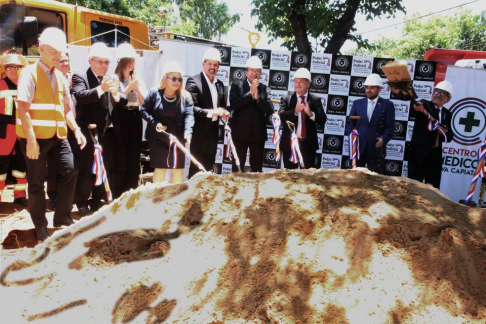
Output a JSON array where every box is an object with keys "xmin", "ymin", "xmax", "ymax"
[{"xmin": 114, "ymin": 43, "xmax": 147, "ymax": 193}]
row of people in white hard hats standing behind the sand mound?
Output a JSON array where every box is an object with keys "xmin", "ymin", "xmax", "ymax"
[{"xmin": 0, "ymin": 28, "xmax": 452, "ymax": 241}]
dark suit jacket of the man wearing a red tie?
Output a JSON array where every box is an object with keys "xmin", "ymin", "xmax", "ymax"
[{"xmin": 278, "ymin": 93, "xmax": 327, "ymax": 151}]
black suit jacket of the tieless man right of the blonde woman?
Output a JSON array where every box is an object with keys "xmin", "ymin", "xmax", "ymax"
[{"xmin": 186, "ymin": 72, "xmax": 226, "ymax": 140}]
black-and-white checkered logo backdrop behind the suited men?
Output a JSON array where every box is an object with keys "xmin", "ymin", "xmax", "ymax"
[{"xmin": 209, "ymin": 47, "xmax": 436, "ymax": 176}]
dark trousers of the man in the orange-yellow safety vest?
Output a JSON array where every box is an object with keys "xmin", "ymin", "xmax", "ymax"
[{"xmin": 20, "ymin": 138, "xmax": 78, "ymax": 229}]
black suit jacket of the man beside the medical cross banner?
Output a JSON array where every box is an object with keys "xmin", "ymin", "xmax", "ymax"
[{"xmin": 410, "ymin": 100, "xmax": 453, "ymax": 161}]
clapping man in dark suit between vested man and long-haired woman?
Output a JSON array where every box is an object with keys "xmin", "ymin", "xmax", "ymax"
[{"xmin": 72, "ymin": 43, "xmax": 127, "ymax": 216}]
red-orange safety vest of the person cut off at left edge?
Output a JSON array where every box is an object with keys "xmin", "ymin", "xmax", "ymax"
[{"xmin": 0, "ymin": 80, "xmax": 17, "ymax": 155}]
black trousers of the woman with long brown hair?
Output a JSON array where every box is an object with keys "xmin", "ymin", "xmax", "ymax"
[{"xmin": 117, "ymin": 108, "xmax": 143, "ymax": 193}]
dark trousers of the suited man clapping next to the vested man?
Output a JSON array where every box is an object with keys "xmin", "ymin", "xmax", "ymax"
[{"xmin": 69, "ymin": 125, "xmax": 106, "ymax": 209}]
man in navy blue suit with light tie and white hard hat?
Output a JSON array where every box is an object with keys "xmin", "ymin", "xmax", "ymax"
[{"xmin": 346, "ymin": 74, "xmax": 395, "ymax": 174}]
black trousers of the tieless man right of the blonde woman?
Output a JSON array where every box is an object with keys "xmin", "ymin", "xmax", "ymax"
[{"xmin": 188, "ymin": 124, "xmax": 218, "ymax": 178}]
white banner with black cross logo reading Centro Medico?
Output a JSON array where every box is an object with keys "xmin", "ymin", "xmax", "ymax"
[{"xmin": 440, "ymin": 66, "xmax": 486, "ymax": 202}]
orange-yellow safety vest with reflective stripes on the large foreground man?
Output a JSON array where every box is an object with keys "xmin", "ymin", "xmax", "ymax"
[{"xmin": 17, "ymin": 64, "xmax": 67, "ymax": 139}]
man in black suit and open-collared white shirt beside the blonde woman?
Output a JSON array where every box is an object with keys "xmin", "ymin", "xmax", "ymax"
[{"xmin": 186, "ymin": 48, "xmax": 229, "ymax": 178}]
